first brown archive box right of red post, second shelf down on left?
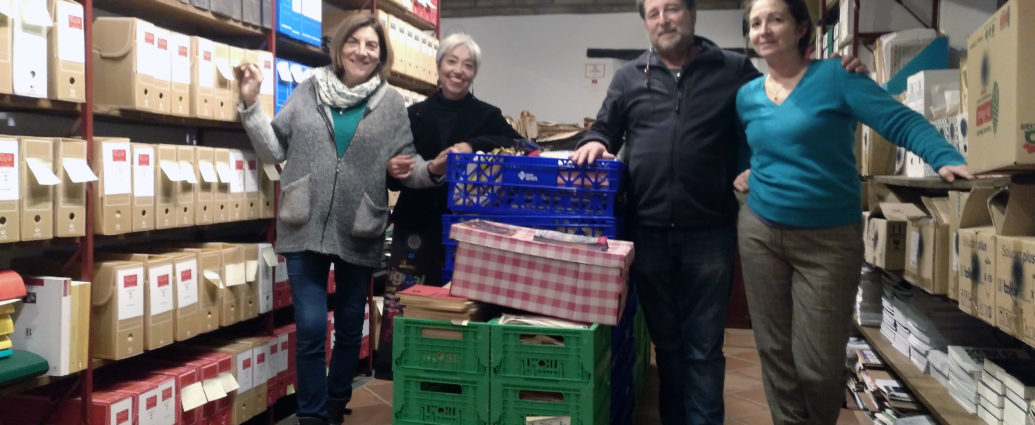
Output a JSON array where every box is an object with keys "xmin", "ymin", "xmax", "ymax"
[{"xmin": 92, "ymin": 138, "xmax": 132, "ymax": 235}]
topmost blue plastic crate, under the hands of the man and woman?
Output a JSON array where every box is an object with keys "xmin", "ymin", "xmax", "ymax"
[{"xmin": 446, "ymin": 153, "xmax": 622, "ymax": 216}]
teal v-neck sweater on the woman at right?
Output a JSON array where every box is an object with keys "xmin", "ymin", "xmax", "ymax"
[{"xmin": 737, "ymin": 59, "xmax": 965, "ymax": 227}]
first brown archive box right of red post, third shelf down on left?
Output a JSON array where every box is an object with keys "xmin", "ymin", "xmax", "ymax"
[{"xmin": 90, "ymin": 262, "xmax": 145, "ymax": 360}]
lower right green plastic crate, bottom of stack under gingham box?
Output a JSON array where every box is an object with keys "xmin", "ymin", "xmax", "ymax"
[{"xmin": 489, "ymin": 376, "xmax": 611, "ymax": 425}]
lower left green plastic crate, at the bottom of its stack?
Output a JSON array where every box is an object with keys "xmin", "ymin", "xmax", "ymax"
[{"xmin": 392, "ymin": 368, "xmax": 490, "ymax": 425}]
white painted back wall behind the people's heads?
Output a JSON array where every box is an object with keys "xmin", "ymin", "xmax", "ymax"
[{"xmin": 442, "ymin": 10, "xmax": 744, "ymax": 123}]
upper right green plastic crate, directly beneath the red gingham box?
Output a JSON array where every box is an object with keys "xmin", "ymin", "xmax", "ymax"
[{"xmin": 489, "ymin": 320, "xmax": 611, "ymax": 383}]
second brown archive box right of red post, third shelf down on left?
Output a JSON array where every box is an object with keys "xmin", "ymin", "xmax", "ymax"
[{"xmin": 96, "ymin": 253, "xmax": 176, "ymax": 350}]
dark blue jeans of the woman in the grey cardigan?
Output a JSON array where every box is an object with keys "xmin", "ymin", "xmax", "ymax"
[{"xmin": 284, "ymin": 251, "xmax": 373, "ymax": 418}]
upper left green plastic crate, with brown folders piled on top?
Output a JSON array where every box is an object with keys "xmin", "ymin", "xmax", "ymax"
[{"xmin": 392, "ymin": 316, "xmax": 491, "ymax": 377}]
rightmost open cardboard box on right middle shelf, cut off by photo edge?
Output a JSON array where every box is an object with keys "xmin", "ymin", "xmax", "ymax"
[{"xmin": 988, "ymin": 183, "xmax": 1035, "ymax": 341}]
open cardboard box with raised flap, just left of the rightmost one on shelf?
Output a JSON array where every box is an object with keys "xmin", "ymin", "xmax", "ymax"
[{"xmin": 958, "ymin": 187, "xmax": 997, "ymax": 325}]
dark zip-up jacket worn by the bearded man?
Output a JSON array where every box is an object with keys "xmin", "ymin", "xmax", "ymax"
[{"xmin": 580, "ymin": 37, "xmax": 760, "ymax": 227}]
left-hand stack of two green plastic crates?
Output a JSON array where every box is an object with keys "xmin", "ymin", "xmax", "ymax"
[{"xmin": 392, "ymin": 316, "xmax": 494, "ymax": 425}]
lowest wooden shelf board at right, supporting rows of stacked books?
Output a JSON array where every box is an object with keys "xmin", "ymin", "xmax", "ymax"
[{"xmin": 858, "ymin": 326, "xmax": 985, "ymax": 425}]
